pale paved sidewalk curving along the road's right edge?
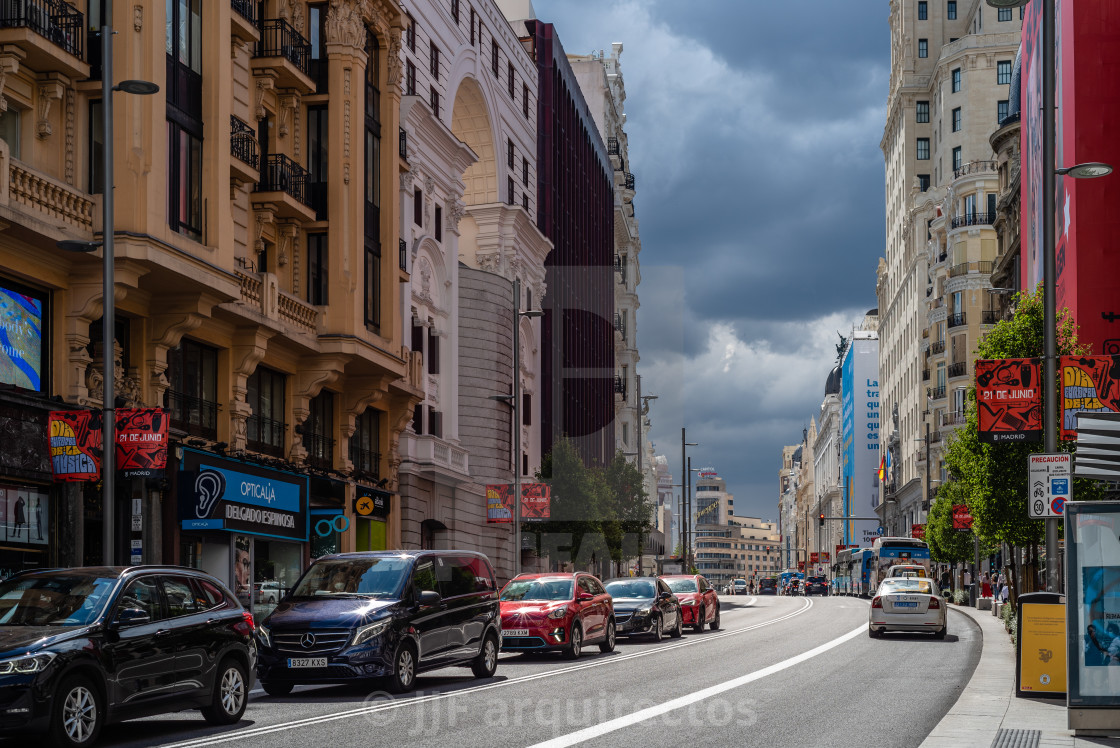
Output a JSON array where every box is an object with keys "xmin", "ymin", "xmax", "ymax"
[{"xmin": 922, "ymin": 605, "xmax": 1120, "ymax": 748}]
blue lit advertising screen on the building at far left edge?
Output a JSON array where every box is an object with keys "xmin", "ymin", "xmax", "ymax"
[{"xmin": 0, "ymin": 281, "xmax": 45, "ymax": 391}]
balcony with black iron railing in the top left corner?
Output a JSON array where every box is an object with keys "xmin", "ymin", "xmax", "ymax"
[{"xmin": 0, "ymin": 0, "xmax": 90, "ymax": 78}]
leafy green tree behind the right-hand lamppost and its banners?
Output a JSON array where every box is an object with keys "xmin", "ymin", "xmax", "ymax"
[{"xmin": 939, "ymin": 288, "xmax": 1102, "ymax": 591}]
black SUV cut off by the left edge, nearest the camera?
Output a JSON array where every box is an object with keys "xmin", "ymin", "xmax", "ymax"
[{"xmin": 0, "ymin": 567, "xmax": 256, "ymax": 746}]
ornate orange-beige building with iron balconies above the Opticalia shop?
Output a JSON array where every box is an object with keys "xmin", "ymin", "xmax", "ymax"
[{"xmin": 0, "ymin": 0, "xmax": 424, "ymax": 595}]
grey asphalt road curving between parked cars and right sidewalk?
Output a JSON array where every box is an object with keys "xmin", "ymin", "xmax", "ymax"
[{"xmin": 32, "ymin": 597, "xmax": 980, "ymax": 748}]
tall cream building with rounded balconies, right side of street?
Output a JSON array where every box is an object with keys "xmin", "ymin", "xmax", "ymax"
[{"xmin": 876, "ymin": 0, "xmax": 1021, "ymax": 535}]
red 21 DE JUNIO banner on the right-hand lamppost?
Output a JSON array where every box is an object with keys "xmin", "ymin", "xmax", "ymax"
[{"xmin": 976, "ymin": 358, "xmax": 1043, "ymax": 445}]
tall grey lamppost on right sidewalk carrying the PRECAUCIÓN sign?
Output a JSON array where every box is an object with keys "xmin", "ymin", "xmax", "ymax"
[{"xmin": 1028, "ymin": 0, "xmax": 1060, "ymax": 592}]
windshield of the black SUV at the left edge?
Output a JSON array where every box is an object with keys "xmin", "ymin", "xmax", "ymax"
[{"xmin": 0, "ymin": 573, "xmax": 116, "ymax": 626}]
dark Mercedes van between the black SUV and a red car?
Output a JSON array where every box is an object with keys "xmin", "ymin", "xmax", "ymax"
[{"xmin": 256, "ymin": 551, "xmax": 501, "ymax": 695}]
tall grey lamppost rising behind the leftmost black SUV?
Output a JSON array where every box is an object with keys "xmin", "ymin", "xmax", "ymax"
[{"xmin": 101, "ymin": 7, "xmax": 116, "ymax": 567}]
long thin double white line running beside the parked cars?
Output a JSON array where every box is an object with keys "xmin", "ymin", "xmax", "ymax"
[{"xmin": 167, "ymin": 599, "xmax": 813, "ymax": 748}]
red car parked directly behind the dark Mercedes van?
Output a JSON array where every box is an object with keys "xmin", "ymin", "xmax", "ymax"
[{"xmin": 500, "ymin": 572, "xmax": 615, "ymax": 660}]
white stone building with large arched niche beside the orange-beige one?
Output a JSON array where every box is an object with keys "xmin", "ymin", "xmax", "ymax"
[{"xmin": 394, "ymin": 0, "xmax": 550, "ymax": 577}]
